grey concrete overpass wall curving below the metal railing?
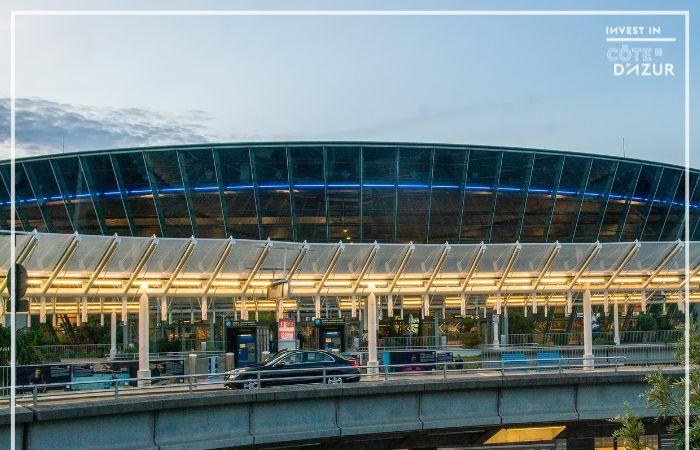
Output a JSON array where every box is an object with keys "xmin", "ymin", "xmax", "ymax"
[{"xmin": 0, "ymin": 368, "xmax": 682, "ymax": 450}]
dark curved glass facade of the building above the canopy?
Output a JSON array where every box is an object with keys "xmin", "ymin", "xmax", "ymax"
[{"xmin": 0, "ymin": 143, "xmax": 700, "ymax": 243}]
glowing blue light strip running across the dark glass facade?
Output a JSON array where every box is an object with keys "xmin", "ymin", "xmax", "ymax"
[{"xmin": 2, "ymin": 182, "xmax": 700, "ymax": 209}]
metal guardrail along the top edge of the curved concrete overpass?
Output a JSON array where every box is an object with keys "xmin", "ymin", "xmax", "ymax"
[{"xmin": 0, "ymin": 356, "xmax": 678, "ymax": 406}]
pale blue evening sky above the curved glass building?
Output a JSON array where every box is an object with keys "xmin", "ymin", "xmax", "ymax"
[{"xmin": 0, "ymin": 0, "xmax": 700, "ymax": 167}]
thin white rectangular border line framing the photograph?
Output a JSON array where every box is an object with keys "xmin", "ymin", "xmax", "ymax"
[{"xmin": 8, "ymin": 10, "xmax": 690, "ymax": 450}]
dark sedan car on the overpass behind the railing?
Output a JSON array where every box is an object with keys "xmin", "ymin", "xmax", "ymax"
[{"xmin": 224, "ymin": 350, "xmax": 360, "ymax": 389}]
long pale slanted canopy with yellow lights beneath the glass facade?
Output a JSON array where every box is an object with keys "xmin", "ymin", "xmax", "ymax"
[{"xmin": 0, "ymin": 232, "xmax": 700, "ymax": 305}]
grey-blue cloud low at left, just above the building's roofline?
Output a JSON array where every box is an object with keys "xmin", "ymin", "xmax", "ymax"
[{"xmin": 0, "ymin": 97, "xmax": 230, "ymax": 157}]
